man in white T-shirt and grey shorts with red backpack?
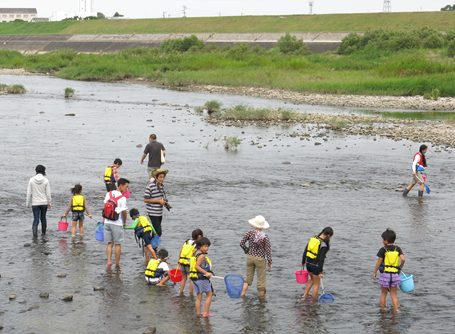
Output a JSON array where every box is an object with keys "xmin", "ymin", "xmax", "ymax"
[{"xmin": 104, "ymin": 178, "xmax": 130, "ymax": 266}]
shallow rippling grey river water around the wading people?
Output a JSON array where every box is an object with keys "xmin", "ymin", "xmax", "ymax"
[{"xmin": 0, "ymin": 76, "xmax": 455, "ymax": 333}]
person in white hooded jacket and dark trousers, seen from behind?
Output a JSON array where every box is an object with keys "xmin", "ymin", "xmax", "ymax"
[{"xmin": 26, "ymin": 165, "xmax": 51, "ymax": 238}]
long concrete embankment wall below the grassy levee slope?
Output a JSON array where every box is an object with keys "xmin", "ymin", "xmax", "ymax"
[{"xmin": 0, "ymin": 33, "xmax": 348, "ymax": 53}]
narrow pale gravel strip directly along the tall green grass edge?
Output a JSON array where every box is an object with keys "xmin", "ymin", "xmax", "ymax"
[{"xmin": 188, "ymin": 85, "xmax": 455, "ymax": 111}]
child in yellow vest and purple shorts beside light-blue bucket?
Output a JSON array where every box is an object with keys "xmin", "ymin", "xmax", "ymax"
[{"xmin": 373, "ymin": 229, "xmax": 405, "ymax": 311}]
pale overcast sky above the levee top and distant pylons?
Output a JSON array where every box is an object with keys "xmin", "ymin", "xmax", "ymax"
[{"xmin": 7, "ymin": 0, "xmax": 455, "ymax": 18}]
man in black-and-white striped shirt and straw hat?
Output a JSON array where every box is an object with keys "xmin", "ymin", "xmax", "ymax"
[{"xmin": 144, "ymin": 168, "xmax": 169, "ymax": 236}]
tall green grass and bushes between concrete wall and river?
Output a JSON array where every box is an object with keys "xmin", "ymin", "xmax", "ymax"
[{"xmin": 0, "ymin": 48, "xmax": 455, "ymax": 97}]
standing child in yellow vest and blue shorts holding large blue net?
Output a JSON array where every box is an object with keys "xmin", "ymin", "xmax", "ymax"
[{"xmin": 190, "ymin": 237, "xmax": 214, "ymax": 317}]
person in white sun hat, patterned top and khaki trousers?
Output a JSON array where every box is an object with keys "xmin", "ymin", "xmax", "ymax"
[{"xmin": 240, "ymin": 216, "xmax": 272, "ymax": 297}]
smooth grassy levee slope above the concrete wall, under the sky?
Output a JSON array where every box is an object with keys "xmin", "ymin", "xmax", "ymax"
[{"xmin": 0, "ymin": 12, "xmax": 455, "ymax": 35}]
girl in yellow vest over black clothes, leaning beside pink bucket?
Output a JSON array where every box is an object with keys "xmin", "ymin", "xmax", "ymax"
[{"xmin": 302, "ymin": 227, "xmax": 333, "ymax": 299}]
